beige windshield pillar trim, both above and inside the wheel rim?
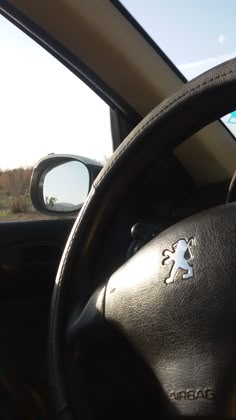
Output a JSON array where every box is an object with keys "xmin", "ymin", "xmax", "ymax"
[{"xmin": 4, "ymin": 0, "xmax": 236, "ymax": 185}]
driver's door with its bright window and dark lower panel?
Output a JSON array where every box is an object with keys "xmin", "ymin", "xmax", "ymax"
[{"xmin": 0, "ymin": 9, "xmax": 133, "ymax": 418}]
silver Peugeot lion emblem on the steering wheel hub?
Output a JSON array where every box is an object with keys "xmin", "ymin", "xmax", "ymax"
[{"xmin": 162, "ymin": 238, "xmax": 194, "ymax": 284}]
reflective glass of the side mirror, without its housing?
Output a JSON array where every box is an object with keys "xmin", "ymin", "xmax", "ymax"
[{"xmin": 43, "ymin": 160, "xmax": 90, "ymax": 213}]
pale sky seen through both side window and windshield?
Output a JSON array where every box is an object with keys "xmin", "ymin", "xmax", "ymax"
[{"xmin": 0, "ymin": 0, "xmax": 236, "ymax": 169}]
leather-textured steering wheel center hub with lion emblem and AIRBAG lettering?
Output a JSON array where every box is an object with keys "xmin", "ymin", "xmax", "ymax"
[{"xmin": 105, "ymin": 204, "xmax": 236, "ymax": 414}]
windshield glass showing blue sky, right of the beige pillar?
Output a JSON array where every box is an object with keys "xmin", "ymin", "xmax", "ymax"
[{"xmin": 122, "ymin": 0, "xmax": 236, "ymax": 137}]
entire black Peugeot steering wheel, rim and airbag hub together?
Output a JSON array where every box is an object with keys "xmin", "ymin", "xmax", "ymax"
[{"xmin": 49, "ymin": 59, "xmax": 236, "ymax": 420}]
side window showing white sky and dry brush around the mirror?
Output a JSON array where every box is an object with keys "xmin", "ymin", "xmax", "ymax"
[{"xmin": 0, "ymin": 15, "xmax": 112, "ymax": 222}]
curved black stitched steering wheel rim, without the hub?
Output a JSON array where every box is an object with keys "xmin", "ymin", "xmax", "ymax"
[{"xmin": 49, "ymin": 59, "xmax": 236, "ymax": 419}]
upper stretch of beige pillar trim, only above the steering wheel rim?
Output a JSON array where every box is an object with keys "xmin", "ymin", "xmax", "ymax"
[{"xmin": 6, "ymin": 0, "xmax": 181, "ymax": 115}]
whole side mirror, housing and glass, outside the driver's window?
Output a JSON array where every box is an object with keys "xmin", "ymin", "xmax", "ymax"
[{"xmin": 30, "ymin": 154, "xmax": 102, "ymax": 215}]
